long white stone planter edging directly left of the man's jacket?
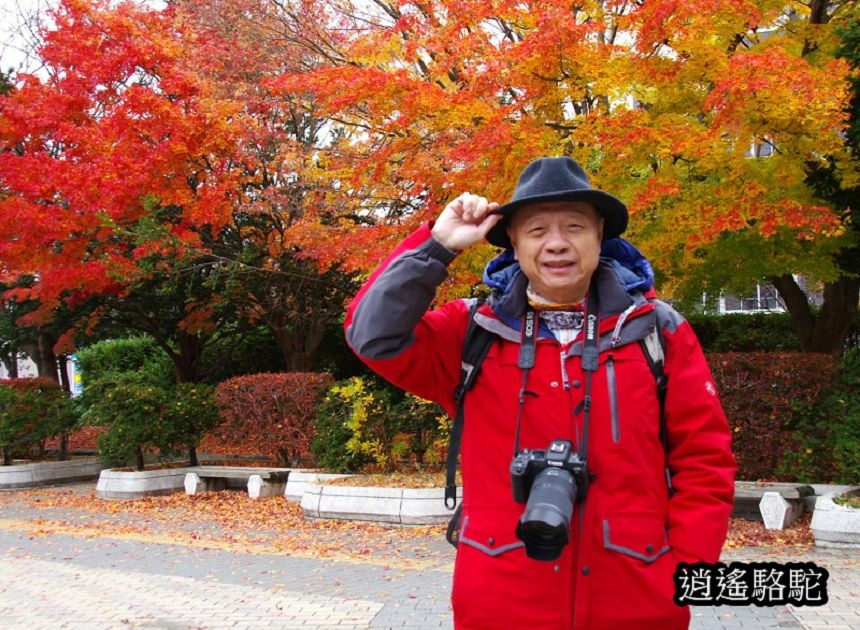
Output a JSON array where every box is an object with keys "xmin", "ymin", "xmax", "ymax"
[{"xmin": 301, "ymin": 483, "xmax": 464, "ymax": 525}]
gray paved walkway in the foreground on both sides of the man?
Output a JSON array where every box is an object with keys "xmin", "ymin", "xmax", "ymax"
[{"xmin": 0, "ymin": 486, "xmax": 860, "ymax": 630}]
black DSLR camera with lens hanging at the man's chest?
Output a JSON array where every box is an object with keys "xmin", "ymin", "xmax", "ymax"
[{"xmin": 511, "ymin": 440, "xmax": 588, "ymax": 560}]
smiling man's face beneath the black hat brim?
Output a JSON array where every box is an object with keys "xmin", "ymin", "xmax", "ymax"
[{"xmin": 508, "ymin": 201, "xmax": 603, "ymax": 304}]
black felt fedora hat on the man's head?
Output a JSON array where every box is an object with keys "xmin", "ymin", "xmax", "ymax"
[{"xmin": 487, "ymin": 157, "xmax": 627, "ymax": 248}]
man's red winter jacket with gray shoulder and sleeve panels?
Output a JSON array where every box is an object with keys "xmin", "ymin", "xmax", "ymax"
[{"xmin": 346, "ymin": 226, "xmax": 736, "ymax": 630}]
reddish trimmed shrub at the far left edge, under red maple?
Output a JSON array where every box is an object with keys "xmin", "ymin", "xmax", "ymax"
[{"xmin": 0, "ymin": 378, "xmax": 77, "ymax": 466}]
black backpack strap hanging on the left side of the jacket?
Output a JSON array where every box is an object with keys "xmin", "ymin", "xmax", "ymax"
[{"xmin": 445, "ymin": 299, "xmax": 496, "ymax": 510}]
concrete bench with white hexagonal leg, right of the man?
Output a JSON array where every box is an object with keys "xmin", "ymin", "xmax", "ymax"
[{"xmin": 732, "ymin": 481, "xmax": 815, "ymax": 529}]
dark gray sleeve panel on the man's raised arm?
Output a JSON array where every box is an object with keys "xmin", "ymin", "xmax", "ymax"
[{"xmin": 346, "ymin": 238, "xmax": 456, "ymax": 360}]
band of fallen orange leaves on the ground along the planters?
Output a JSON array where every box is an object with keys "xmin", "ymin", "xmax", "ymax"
[{"xmin": 0, "ymin": 486, "xmax": 814, "ymax": 568}]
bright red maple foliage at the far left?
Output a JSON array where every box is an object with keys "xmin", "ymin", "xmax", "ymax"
[{"xmin": 0, "ymin": 0, "xmax": 249, "ymax": 380}]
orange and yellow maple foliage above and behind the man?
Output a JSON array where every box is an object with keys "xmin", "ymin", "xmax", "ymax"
[{"xmin": 273, "ymin": 0, "xmax": 858, "ymax": 352}]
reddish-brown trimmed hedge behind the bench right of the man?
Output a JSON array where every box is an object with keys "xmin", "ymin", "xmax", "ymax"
[{"xmin": 708, "ymin": 352, "xmax": 838, "ymax": 480}]
